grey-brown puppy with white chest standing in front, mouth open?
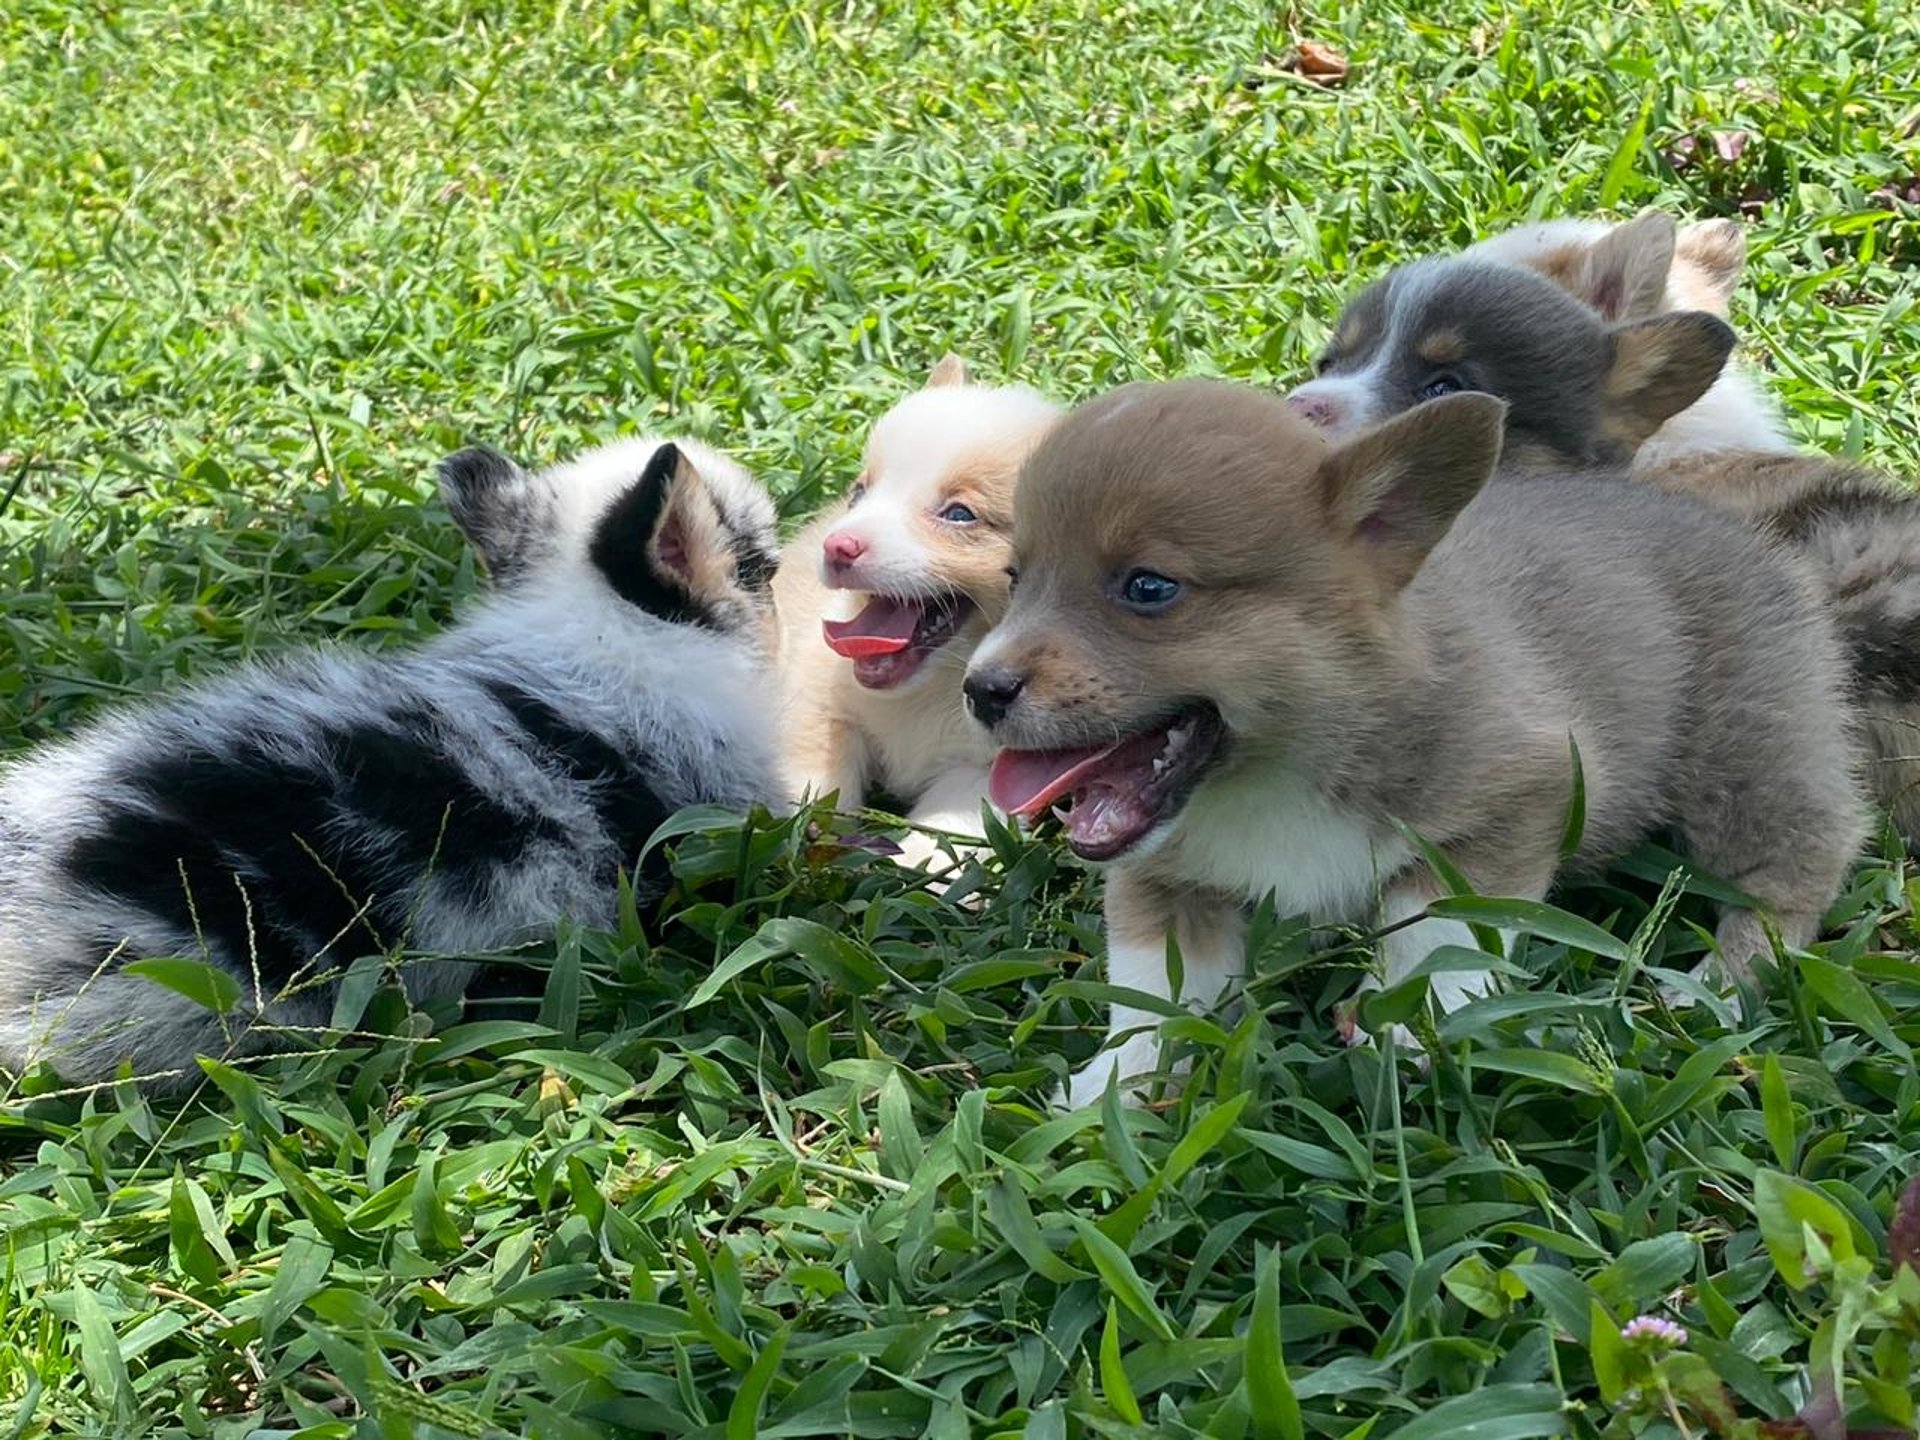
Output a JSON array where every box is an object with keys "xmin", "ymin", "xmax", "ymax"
[{"xmin": 966, "ymin": 382, "xmax": 1862, "ymax": 1104}]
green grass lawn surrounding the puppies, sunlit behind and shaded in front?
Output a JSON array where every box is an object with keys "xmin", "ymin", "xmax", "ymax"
[{"xmin": 0, "ymin": 0, "xmax": 1920, "ymax": 1440}]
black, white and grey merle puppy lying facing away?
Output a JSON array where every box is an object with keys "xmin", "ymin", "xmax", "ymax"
[{"xmin": 0, "ymin": 440, "xmax": 778, "ymax": 1081}]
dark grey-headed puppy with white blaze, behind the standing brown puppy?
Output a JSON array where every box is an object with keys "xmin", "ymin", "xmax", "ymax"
[{"xmin": 1288, "ymin": 213, "xmax": 1920, "ymax": 835}]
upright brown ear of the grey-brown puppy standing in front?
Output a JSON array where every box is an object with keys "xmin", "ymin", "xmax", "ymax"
[{"xmin": 1319, "ymin": 394, "xmax": 1507, "ymax": 589}]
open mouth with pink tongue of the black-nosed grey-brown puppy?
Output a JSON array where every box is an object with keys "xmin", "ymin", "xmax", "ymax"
[{"xmin": 987, "ymin": 703, "xmax": 1227, "ymax": 860}]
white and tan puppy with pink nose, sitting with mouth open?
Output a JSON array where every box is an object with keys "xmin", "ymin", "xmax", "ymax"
[{"xmin": 774, "ymin": 355, "xmax": 1060, "ymax": 864}]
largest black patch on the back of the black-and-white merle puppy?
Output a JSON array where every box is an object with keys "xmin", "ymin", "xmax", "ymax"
[{"xmin": 63, "ymin": 710, "xmax": 551, "ymax": 989}]
